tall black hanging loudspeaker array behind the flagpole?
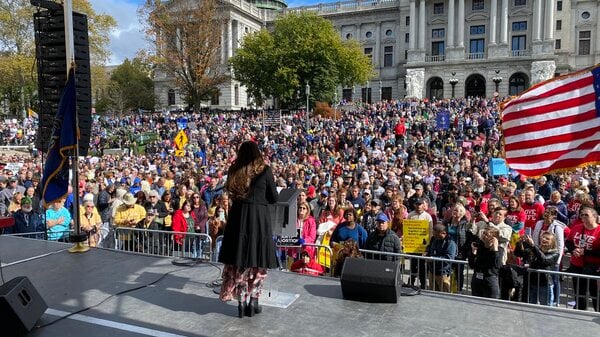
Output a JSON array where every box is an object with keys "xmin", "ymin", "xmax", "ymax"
[{"xmin": 33, "ymin": 6, "xmax": 92, "ymax": 156}]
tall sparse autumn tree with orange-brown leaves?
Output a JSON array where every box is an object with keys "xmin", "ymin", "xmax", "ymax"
[{"xmin": 140, "ymin": 0, "xmax": 229, "ymax": 107}]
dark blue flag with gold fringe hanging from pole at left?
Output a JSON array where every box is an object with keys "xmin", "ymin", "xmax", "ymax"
[{"xmin": 42, "ymin": 69, "xmax": 79, "ymax": 205}]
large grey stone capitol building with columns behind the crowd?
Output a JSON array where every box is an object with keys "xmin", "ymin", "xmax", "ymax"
[{"xmin": 155, "ymin": 0, "xmax": 600, "ymax": 110}]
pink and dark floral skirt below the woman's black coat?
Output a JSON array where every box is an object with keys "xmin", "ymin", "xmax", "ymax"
[{"xmin": 220, "ymin": 264, "xmax": 267, "ymax": 302}]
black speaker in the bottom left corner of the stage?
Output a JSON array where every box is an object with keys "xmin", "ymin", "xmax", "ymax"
[{"xmin": 0, "ymin": 276, "xmax": 48, "ymax": 337}]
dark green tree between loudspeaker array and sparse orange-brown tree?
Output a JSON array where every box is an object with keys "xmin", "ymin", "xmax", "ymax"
[{"xmin": 96, "ymin": 58, "xmax": 156, "ymax": 114}]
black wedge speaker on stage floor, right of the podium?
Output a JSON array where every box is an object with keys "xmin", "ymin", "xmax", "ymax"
[{"xmin": 341, "ymin": 257, "xmax": 400, "ymax": 303}]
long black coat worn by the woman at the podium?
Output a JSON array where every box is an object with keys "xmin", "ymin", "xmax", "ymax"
[{"xmin": 219, "ymin": 166, "xmax": 278, "ymax": 268}]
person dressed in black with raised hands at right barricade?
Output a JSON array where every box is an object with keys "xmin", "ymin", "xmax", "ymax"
[{"xmin": 468, "ymin": 227, "xmax": 504, "ymax": 299}]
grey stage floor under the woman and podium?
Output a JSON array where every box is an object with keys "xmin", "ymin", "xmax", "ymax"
[{"xmin": 0, "ymin": 236, "xmax": 600, "ymax": 337}]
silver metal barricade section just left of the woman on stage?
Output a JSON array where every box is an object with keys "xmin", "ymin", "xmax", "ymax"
[{"xmin": 114, "ymin": 227, "xmax": 213, "ymax": 260}]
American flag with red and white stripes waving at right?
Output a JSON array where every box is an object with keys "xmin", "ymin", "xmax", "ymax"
[{"xmin": 501, "ymin": 65, "xmax": 600, "ymax": 177}]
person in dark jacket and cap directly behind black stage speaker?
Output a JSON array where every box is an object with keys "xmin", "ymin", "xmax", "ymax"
[{"xmin": 365, "ymin": 213, "xmax": 402, "ymax": 261}]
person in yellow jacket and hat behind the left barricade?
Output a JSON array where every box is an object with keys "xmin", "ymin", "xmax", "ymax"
[{"xmin": 115, "ymin": 192, "xmax": 146, "ymax": 251}]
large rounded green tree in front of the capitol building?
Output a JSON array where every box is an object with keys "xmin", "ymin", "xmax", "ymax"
[{"xmin": 230, "ymin": 12, "xmax": 373, "ymax": 106}]
